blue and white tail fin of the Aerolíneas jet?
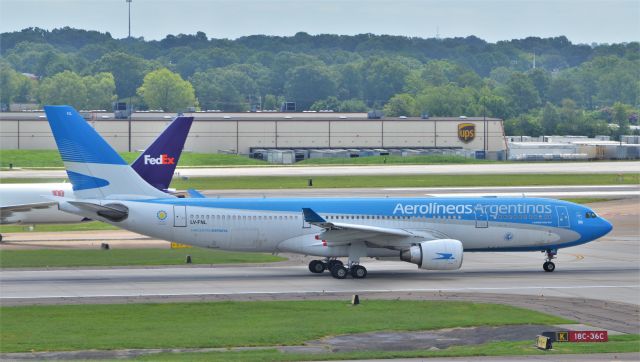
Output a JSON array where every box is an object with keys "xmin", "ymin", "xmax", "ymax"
[{"xmin": 45, "ymin": 106, "xmax": 171, "ymax": 199}]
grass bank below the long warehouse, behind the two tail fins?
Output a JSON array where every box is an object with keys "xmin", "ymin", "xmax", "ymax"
[{"xmin": 0, "ymin": 150, "xmax": 267, "ymax": 168}]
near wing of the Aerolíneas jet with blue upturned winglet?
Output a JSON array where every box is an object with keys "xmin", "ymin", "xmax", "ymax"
[{"xmin": 302, "ymin": 208, "xmax": 436, "ymax": 247}]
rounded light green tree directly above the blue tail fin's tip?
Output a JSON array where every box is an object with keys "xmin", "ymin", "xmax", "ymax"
[{"xmin": 37, "ymin": 70, "xmax": 87, "ymax": 109}]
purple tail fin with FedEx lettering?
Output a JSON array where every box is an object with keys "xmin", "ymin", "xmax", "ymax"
[{"xmin": 131, "ymin": 116, "xmax": 193, "ymax": 191}]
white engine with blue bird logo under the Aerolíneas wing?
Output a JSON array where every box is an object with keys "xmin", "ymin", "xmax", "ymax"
[{"xmin": 400, "ymin": 239, "xmax": 463, "ymax": 270}]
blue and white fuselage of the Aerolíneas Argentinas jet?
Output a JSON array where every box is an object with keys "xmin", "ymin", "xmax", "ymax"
[{"xmin": 94, "ymin": 198, "xmax": 611, "ymax": 257}]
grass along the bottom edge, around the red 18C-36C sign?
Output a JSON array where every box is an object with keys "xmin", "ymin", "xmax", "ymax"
[{"xmin": 137, "ymin": 334, "xmax": 640, "ymax": 362}]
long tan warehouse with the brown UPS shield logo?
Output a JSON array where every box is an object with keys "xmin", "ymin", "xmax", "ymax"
[{"xmin": 0, "ymin": 112, "xmax": 507, "ymax": 159}]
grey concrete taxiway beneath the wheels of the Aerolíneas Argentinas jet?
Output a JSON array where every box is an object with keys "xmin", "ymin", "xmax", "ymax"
[{"xmin": 0, "ymin": 198, "xmax": 640, "ymax": 333}]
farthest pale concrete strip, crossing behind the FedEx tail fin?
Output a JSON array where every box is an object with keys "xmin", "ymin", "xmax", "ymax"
[{"xmin": 0, "ymin": 161, "xmax": 640, "ymax": 179}]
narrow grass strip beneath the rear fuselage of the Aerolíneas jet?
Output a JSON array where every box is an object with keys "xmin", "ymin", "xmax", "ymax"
[{"xmin": 0, "ymin": 248, "xmax": 286, "ymax": 269}]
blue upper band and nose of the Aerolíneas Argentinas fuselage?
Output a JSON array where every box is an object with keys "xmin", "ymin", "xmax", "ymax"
[{"xmin": 130, "ymin": 197, "xmax": 611, "ymax": 251}]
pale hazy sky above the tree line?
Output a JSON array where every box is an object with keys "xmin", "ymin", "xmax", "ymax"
[{"xmin": 0, "ymin": 0, "xmax": 640, "ymax": 44}]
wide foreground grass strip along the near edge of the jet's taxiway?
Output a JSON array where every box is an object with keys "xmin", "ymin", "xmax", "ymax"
[{"xmin": 0, "ymin": 300, "xmax": 571, "ymax": 357}]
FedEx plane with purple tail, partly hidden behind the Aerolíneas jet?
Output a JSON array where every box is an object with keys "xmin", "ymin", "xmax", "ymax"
[{"xmin": 0, "ymin": 116, "xmax": 193, "ymax": 242}]
